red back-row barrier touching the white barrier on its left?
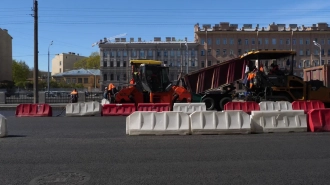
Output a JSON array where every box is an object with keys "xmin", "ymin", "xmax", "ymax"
[{"xmin": 102, "ymin": 103, "xmax": 136, "ymax": 116}]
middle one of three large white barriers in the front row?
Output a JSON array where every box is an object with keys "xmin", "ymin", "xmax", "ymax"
[{"xmin": 190, "ymin": 110, "xmax": 251, "ymax": 134}]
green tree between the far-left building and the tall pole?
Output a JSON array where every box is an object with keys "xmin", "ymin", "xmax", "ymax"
[{"xmin": 12, "ymin": 60, "xmax": 30, "ymax": 87}]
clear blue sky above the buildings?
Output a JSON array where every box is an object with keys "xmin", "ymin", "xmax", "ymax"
[{"xmin": 0, "ymin": 0, "xmax": 330, "ymax": 71}]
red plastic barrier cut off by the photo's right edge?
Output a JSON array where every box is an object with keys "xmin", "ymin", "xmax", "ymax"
[{"xmin": 308, "ymin": 109, "xmax": 330, "ymax": 132}]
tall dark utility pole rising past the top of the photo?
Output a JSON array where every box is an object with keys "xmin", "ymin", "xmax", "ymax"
[{"xmin": 33, "ymin": 0, "xmax": 39, "ymax": 103}]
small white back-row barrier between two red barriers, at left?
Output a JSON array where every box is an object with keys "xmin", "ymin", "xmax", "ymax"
[{"xmin": 66, "ymin": 101, "xmax": 101, "ymax": 116}]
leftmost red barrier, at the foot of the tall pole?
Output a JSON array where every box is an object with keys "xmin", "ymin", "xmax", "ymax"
[{"xmin": 15, "ymin": 104, "xmax": 53, "ymax": 117}]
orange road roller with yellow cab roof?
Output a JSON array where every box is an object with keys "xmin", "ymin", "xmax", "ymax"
[{"xmin": 115, "ymin": 59, "xmax": 186, "ymax": 105}]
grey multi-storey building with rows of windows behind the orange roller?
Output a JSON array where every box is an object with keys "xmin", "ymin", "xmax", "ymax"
[{"xmin": 99, "ymin": 37, "xmax": 200, "ymax": 89}]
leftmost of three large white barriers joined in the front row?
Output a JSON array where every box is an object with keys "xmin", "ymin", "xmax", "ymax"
[{"xmin": 126, "ymin": 111, "xmax": 190, "ymax": 135}]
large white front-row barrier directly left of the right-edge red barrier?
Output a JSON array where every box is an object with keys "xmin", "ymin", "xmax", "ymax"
[{"xmin": 251, "ymin": 110, "xmax": 307, "ymax": 133}]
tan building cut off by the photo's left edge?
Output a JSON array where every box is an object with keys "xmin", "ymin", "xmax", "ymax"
[{"xmin": 0, "ymin": 28, "xmax": 13, "ymax": 82}]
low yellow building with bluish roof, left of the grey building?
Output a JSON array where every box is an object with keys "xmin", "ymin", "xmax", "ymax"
[{"xmin": 52, "ymin": 69, "xmax": 100, "ymax": 91}]
